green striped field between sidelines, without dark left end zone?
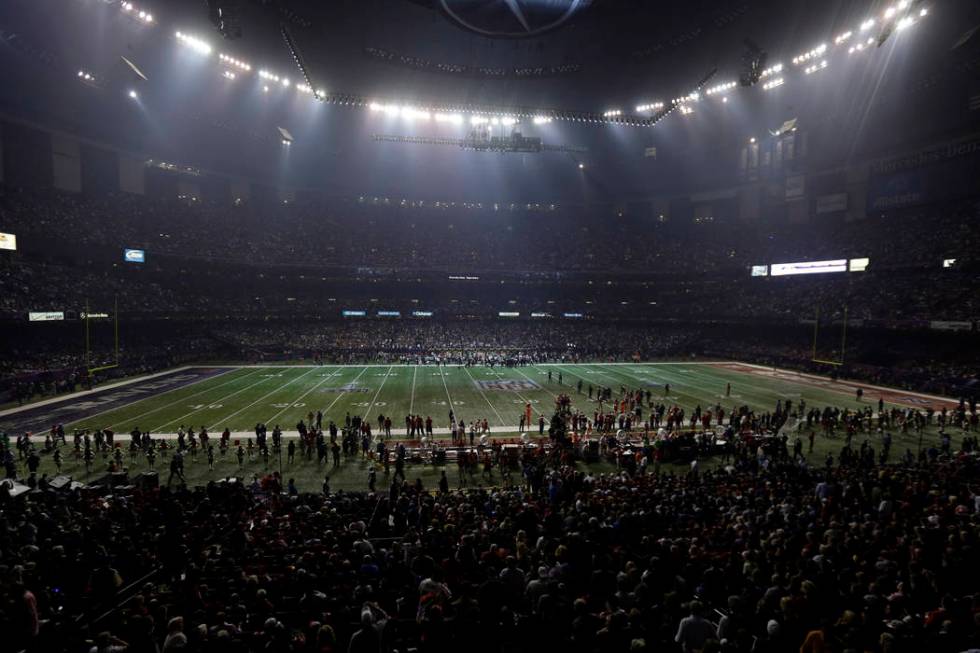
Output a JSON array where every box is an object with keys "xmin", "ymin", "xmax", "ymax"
[{"xmin": 17, "ymin": 362, "xmax": 952, "ymax": 437}]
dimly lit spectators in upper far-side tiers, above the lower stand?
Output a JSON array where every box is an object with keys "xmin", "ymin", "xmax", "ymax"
[{"xmin": 0, "ymin": 189, "xmax": 980, "ymax": 326}]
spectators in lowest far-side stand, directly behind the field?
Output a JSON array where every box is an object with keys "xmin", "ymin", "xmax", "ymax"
[{"xmin": 0, "ymin": 318, "xmax": 980, "ymax": 401}]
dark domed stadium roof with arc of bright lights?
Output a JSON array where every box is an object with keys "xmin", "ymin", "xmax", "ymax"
[{"xmin": 0, "ymin": 0, "xmax": 980, "ymax": 197}]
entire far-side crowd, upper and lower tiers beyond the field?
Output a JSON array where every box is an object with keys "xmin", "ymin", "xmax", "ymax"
[{"xmin": 0, "ymin": 183, "xmax": 980, "ymax": 394}]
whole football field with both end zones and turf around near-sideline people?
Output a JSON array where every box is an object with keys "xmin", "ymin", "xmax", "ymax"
[{"xmin": 0, "ymin": 362, "xmax": 956, "ymax": 491}]
